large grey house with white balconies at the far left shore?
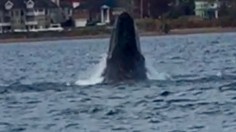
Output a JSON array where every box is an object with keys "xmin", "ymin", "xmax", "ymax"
[{"xmin": 0, "ymin": 0, "xmax": 64, "ymax": 32}]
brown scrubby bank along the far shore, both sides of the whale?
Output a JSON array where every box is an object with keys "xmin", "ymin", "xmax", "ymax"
[{"xmin": 0, "ymin": 18, "xmax": 236, "ymax": 44}]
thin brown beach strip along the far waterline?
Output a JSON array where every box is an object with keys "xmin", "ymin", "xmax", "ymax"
[{"xmin": 0, "ymin": 27, "xmax": 236, "ymax": 44}]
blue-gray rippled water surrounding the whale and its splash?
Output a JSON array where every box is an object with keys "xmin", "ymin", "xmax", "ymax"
[{"xmin": 0, "ymin": 33, "xmax": 236, "ymax": 132}]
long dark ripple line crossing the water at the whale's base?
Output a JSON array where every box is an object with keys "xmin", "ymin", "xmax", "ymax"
[{"xmin": 0, "ymin": 75, "xmax": 236, "ymax": 94}]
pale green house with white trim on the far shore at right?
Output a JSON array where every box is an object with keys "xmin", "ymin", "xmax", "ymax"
[{"xmin": 195, "ymin": 0, "xmax": 220, "ymax": 19}]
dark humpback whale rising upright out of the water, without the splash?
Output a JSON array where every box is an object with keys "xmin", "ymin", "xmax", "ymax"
[{"xmin": 102, "ymin": 12, "xmax": 147, "ymax": 83}]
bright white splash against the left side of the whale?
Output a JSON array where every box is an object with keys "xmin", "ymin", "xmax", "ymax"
[{"xmin": 75, "ymin": 55, "xmax": 107, "ymax": 86}]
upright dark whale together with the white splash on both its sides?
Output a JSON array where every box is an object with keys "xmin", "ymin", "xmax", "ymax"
[{"xmin": 76, "ymin": 12, "xmax": 171, "ymax": 86}]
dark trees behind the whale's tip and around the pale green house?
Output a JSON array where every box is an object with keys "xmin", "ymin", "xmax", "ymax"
[{"xmin": 82, "ymin": 0, "xmax": 236, "ymax": 19}]
